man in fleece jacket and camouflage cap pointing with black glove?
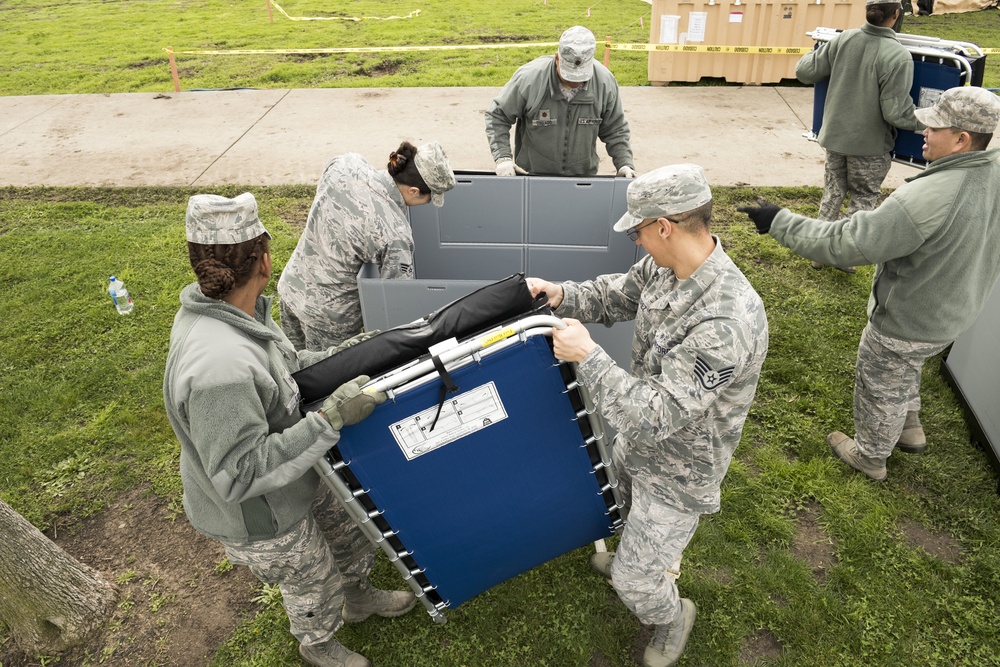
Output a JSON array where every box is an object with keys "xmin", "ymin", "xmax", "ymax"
[{"xmin": 739, "ymin": 87, "xmax": 1000, "ymax": 481}]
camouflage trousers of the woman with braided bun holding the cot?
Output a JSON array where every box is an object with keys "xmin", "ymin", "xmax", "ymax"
[{"xmin": 223, "ymin": 485, "xmax": 375, "ymax": 645}]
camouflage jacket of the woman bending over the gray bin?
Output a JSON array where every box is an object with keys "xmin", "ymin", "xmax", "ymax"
[{"xmin": 278, "ymin": 153, "xmax": 413, "ymax": 339}]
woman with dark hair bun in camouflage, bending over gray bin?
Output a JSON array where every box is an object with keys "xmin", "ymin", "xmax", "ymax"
[{"xmin": 278, "ymin": 141, "xmax": 455, "ymax": 351}]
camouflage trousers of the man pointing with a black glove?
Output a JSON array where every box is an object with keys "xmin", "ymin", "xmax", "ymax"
[{"xmin": 854, "ymin": 324, "xmax": 948, "ymax": 461}]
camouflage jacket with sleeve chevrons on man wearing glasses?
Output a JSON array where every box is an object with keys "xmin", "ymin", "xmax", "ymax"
[{"xmin": 556, "ymin": 238, "xmax": 768, "ymax": 514}]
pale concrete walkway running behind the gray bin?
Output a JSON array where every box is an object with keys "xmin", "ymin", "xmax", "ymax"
[{"xmin": 0, "ymin": 86, "xmax": 917, "ymax": 189}]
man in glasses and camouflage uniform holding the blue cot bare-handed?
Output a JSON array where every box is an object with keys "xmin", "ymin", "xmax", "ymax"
[{"xmin": 528, "ymin": 164, "xmax": 768, "ymax": 667}]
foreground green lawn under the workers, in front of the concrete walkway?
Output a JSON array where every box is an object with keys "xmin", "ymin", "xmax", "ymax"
[{"xmin": 0, "ymin": 186, "xmax": 1000, "ymax": 667}]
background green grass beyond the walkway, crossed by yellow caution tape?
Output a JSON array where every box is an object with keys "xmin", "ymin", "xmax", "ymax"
[{"xmin": 0, "ymin": 0, "xmax": 1000, "ymax": 95}]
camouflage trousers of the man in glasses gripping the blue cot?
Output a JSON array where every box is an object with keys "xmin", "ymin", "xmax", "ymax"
[{"xmin": 611, "ymin": 446, "xmax": 700, "ymax": 625}]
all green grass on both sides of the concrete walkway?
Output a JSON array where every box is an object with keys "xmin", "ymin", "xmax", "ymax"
[{"xmin": 0, "ymin": 0, "xmax": 1000, "ymax": 667}]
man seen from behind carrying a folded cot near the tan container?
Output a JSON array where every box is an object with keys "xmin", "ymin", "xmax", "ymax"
[{"xmin": 795, "ymin": 0, "xmax": 922, "ymax": 273}]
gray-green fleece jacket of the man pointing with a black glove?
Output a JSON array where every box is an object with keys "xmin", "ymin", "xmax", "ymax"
[{"xmin": 769, "ymin": 148, "xmax": 1000, "ymax": 344}]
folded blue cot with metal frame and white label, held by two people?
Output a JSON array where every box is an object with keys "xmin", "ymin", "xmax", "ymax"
[{"xmin": 292, "ymin": 277, "xmax": 623, "ymax": 623}]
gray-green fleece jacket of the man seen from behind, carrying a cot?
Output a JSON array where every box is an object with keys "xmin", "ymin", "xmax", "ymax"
[{"xmin": 795, "ymin": 23, "xmax": 923, "ymax": 156}]
